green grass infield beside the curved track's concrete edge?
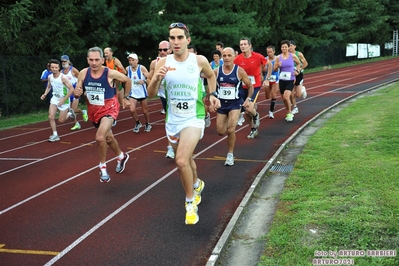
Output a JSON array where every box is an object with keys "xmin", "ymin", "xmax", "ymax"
[{"xmin": 259, "ymin": 83, "xmax": 399, "ymax": 266}]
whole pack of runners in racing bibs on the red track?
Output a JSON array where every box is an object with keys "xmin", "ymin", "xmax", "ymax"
[{"xmin": 41, "ymin": 22, "xmax": 308, "ymax": 224}]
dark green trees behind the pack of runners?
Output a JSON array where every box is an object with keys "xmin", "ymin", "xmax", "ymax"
[{"xmin": 0, "ymin": 0, "xmax": 399, "ymax": 116}]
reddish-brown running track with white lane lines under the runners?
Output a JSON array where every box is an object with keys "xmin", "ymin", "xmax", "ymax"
[{"xmin": 0, "ymin": 58, "xmax": 399, "ymax": 265}]
